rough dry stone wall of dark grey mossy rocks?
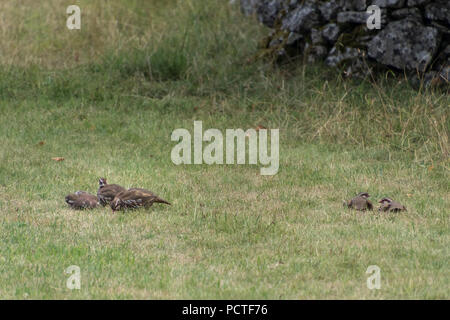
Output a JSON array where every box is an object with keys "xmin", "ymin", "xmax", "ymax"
[{"xmin": 241, "ymin": 0, "xmax": 450, "ymax": 86}]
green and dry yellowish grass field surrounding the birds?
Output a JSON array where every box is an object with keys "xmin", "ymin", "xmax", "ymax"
[{"xmin": 0, "ymin": 0, "xmax": 450, "ymax": 299}]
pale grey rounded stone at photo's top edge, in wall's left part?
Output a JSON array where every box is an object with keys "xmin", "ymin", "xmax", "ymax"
[{"xmin": 282, "ymin": 1, "xmax": 320, "ymax": 33}]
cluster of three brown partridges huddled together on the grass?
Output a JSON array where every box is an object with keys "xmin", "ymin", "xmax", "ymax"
[{"xmin": 66, "ymin": 178, "xmax": 170, "ymax": 212}]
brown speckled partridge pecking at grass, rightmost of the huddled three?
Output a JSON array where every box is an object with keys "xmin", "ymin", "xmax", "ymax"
[{"xmin": 110, "ymin": 188, "xmax": 170, "ymax": 212}]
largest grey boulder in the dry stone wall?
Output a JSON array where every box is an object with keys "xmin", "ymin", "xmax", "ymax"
[{"xmin": 368, "ymin": 19, "xmax": 440, "ymax": 72}]
